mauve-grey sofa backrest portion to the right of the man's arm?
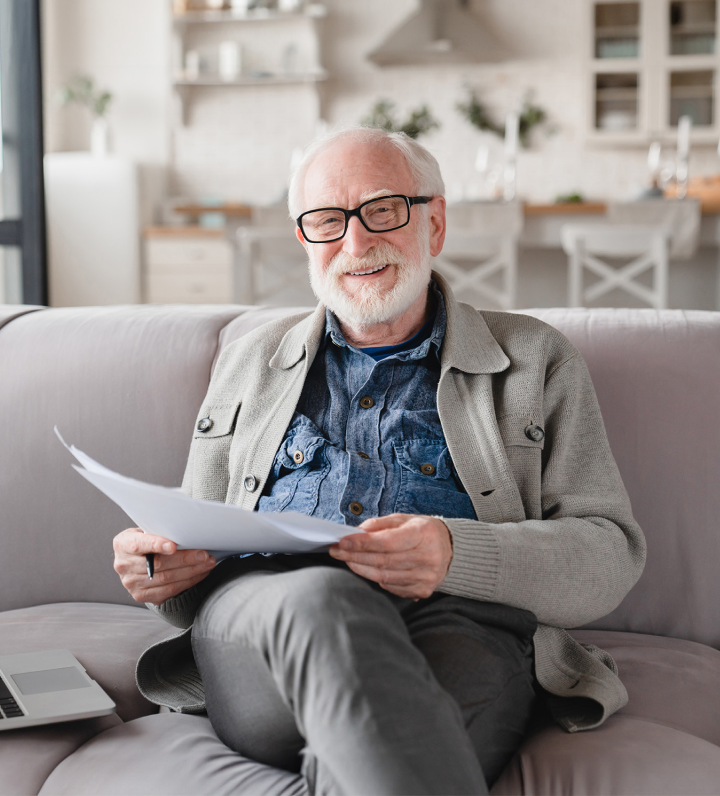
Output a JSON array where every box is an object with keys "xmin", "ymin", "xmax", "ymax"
[{"xmin": 522, "ymin": 309, "xmax": 720, "ymax": 648}]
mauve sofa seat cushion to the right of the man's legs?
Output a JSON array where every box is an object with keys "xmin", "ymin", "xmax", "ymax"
[{"xmin": 492, "ymin": 630, "xmax": 720, "ymax": 796}]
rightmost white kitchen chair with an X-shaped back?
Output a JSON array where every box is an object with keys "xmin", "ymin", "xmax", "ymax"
[{"xmin": 560, "ymin": 224, "xmax": 671, "ymax": 309}]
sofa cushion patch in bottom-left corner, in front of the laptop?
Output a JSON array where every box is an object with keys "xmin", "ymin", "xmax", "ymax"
[{"xmin": 0, "ymin": 714, "xmax": 122, "ymax": 796}]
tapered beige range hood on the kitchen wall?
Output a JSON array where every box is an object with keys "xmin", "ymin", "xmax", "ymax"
[{"xmin": 367, "ymin": 0, "xmax": 508, "ymax": 66}]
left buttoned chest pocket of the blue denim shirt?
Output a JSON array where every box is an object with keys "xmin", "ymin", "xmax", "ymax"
[{"xmin": 258, "ymin": 415, "xmax": 330, "ymax": 515}]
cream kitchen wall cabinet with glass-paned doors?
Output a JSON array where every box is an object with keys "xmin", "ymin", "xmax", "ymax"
[{"xmin": 587, "ymin": 0, "xmax": 720, "ymax": 146}]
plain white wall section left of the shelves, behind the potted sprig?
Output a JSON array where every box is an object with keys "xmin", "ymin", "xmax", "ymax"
[{"xmin": 42, "ymin": 0, "xmax": 171, "ymax": 223}]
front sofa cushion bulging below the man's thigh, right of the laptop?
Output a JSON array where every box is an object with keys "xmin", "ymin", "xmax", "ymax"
[{"xmin": 40, "ymin": 713, "xmax": 307, "ymax": 796}]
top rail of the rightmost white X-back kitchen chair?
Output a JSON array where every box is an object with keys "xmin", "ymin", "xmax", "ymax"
[{"xmin": 560, "ymin": 223, "xmax": 670, "ymax": 257}]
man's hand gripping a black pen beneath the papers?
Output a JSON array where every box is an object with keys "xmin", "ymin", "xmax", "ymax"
[{"xmin": 113, "ymin": 528, "xmax": 215, "ymax": 605}]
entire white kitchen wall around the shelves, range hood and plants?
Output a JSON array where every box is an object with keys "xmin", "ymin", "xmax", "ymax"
[{"xmin": 44, "ymin": 0, "xmax": 720, "ymax": 204}]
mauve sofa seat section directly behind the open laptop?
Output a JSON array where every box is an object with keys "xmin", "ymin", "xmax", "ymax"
[{"xmin": 0, "ymin": 603, "xmax": 179, "ymax": 720}]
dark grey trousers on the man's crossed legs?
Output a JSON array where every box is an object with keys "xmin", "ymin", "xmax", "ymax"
[{"xmin": 192, "ymin": 556, "xmax": 537, "ymax": 794}]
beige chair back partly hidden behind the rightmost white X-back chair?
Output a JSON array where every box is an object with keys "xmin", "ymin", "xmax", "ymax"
[{"xmin": 607, "ymin": 199, "xmax": 701, "ymax": 260}]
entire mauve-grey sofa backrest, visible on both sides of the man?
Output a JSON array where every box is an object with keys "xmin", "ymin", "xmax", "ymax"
[{"xmin": 0, "ymin": 306, "xmax": 720, "ymax": 648}]
